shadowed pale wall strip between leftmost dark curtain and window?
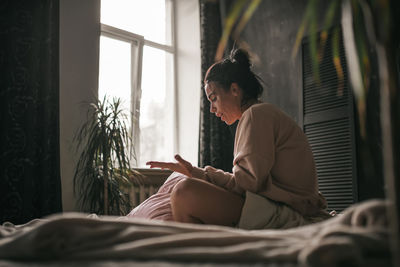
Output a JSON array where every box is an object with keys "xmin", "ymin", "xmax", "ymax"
[{"xmin": 60, "ymin": 0, "xmax": 100, "ymax": 211}]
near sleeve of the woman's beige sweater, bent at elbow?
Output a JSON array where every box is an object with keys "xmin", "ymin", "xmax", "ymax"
[{"xmin": 192, "ymin": 110, "xmax": 275, "ymax": 194}]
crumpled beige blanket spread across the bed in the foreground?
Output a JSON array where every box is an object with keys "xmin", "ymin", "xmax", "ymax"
[{"xmin": 0, "ymin": 200, "xmax": 390, "ymax": 266}]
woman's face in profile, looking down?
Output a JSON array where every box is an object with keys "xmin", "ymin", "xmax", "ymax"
[{"xmin": 205, "ymin": 82, "xmax": 242, "ymax": 125}]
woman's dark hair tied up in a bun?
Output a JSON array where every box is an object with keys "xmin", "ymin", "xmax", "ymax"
[{"xmin": 204, "ymin": 48, "xmax": 264, "ymax": 105}]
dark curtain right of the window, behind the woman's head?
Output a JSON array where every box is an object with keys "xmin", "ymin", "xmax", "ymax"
[{"xmin": 199, "ymin": 0, "xmax": 235, "ymax": 171}]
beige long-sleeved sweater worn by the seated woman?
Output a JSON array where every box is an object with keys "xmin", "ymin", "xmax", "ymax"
[{"xmin": 192, "ymin": 103, "xmax": 326, "ymax": 216}]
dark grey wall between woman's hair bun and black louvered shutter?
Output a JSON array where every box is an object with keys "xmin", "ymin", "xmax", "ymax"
[{"xmin": 241, "ymin": 0, "xmax": 307, "ymax": 124}]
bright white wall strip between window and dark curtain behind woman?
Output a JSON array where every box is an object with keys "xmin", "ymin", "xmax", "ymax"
[{"xmin": 175, "ymin": 0, "xmax": 202, "ymax": 165}]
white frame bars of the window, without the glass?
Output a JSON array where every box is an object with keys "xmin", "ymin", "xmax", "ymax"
[{"xmin": 100, "ymin": 0, "xmax": 179, "ymax": 168}]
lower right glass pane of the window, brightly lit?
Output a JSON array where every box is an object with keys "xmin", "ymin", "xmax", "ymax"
[{"xmin": 139, "ymin": 47, "xmax": 174, "ymax": 167}]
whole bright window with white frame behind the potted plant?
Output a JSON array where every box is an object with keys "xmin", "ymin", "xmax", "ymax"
[{"xmin": 99, "ymin": 0, "xmax": 177, "ymax": 167}]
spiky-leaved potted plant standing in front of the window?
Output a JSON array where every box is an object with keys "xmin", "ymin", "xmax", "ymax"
[{"xmin": 74, "ymin": 96, "xmax": 141, "ymax": 215}]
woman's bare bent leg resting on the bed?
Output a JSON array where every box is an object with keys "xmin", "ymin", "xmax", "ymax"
[{"xmin": 171, "ymin": 178, "xmax": 244, "ymax": 226}]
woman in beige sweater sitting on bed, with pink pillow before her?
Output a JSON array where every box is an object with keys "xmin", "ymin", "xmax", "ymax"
[{"xmin": 128, "ymin": 49, "xmax": 327, "ymax": 228}]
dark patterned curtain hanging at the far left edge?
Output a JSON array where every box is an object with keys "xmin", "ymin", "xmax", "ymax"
[{"xmin": 0, "ymin": 0, "xmax": 62, "ymax": 224}]
